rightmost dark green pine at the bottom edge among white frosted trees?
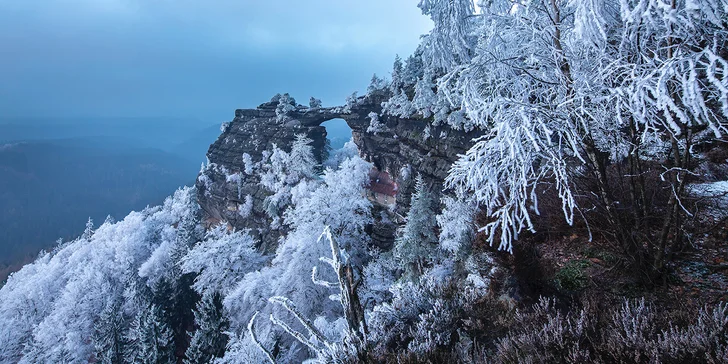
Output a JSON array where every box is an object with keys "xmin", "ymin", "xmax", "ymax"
[{"xmin": 185, "ymin": 293, "xmax": 230, "ymax": 364}]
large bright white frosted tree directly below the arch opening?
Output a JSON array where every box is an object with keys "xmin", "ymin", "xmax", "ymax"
[{"xmin": 224, "ymin": 157, "xmax": 371, "ymax": 362}]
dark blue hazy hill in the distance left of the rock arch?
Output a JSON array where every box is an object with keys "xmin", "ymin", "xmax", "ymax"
[{"xmin": 0, "ymin": 137, "xmax": 199, "ymax": 281}]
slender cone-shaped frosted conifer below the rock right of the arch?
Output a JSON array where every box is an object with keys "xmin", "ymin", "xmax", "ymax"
[{"xmin": 394, "ymin": 175, "xmax": 437, "ymax": 279}]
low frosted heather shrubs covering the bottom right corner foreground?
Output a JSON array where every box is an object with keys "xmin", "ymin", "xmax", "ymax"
[{"xmin": 490, "ymin": 299, "xmax": 728, "ymax": 364}]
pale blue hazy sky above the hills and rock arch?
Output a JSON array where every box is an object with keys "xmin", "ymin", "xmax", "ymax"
[{"xmin": 0, "ymin": 0, "xmax": 431, "ymax": 122}]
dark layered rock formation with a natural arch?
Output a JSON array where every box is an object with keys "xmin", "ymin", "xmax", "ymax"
[{"xmin": 197, "ymin": 93, "xmax": 478, "ymax": 252}]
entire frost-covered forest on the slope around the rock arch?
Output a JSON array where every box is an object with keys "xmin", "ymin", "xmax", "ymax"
[{"xmin": 0, "ymin": 0, "xmax": 728, "ymax": 363}]
